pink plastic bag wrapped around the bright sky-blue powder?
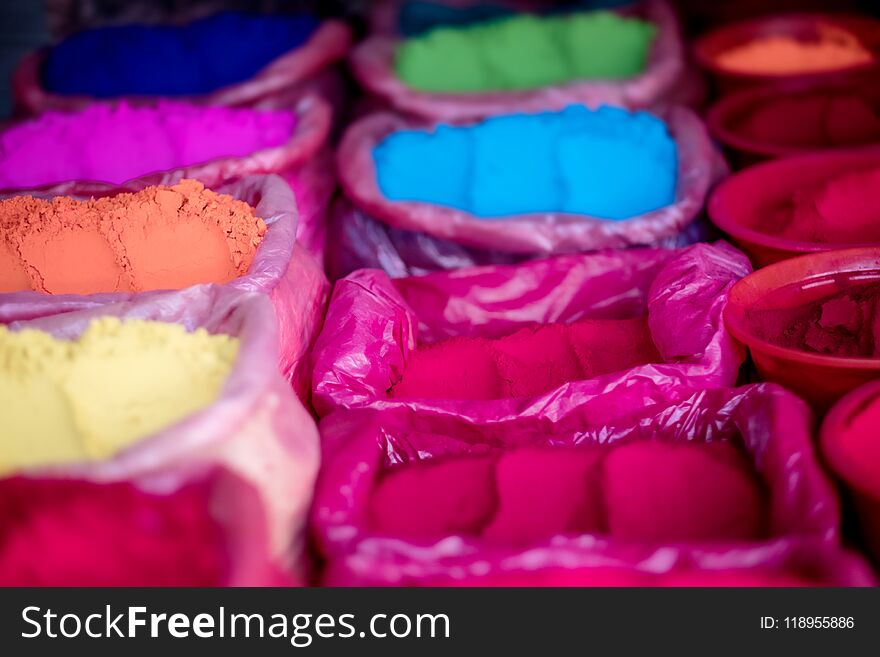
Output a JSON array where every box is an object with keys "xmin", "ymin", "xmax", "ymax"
[{"xmin": 327, "ymin": 107, "xmax": 726, "ymax": 274}]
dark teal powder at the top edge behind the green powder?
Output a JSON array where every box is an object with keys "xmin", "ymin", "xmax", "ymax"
[{"xmin": 398, "ymin": 0, "xmax": 633, "ymax": 37}]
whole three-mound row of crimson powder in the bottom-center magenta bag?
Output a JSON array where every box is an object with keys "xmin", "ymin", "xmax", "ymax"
[{"xmin": 367, "ymin": 441, "xmax": 766, "ymax": 545}]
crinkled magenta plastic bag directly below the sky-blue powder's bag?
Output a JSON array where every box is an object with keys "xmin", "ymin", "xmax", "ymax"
[{"xmin": 313, "ymin": 242, "xmax": 750, "ymax": 423}]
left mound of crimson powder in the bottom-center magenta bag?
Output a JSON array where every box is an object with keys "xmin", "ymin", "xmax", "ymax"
[{"xmin": 367, "ymin": 456, "xmax": 498, "ymax": 539}]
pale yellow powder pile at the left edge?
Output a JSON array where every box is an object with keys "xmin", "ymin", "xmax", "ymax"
[{"xmin": 0, "ymin": 317, "xmax": 238, "ymax": 474}]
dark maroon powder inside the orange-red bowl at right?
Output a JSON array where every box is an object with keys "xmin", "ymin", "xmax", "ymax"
[{"xmin": 746, "ymin": 282, "xmax": 880, "ymax": 358}]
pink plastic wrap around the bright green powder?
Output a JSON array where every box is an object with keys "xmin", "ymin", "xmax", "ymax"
[{"xmin": 350, "ymin": 0, "xmax": 685, "ymax": 121}]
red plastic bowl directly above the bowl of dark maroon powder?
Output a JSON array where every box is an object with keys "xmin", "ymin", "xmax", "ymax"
[{"xmin": 707, "ymin": 146, "xmax": 880, "ymax": 267}]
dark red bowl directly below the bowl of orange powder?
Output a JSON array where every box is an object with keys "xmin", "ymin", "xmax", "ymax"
[{"xmin": 706, "ymin": 80, "xmax": 880, "ymax": 169}]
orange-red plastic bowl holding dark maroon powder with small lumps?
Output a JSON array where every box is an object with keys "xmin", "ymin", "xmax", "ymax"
[{"xmin": 724, "ymin": 247, "xmax": 880, "ymax": 414}]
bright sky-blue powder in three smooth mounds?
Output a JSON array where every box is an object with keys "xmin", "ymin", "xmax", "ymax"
[{"xmin": 373, "ymin": 106, "xmax": 678, "ymax": 220}]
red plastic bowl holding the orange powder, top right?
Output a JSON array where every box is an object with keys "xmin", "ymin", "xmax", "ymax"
[{"xmin": 693, "ymin": 13, "xmax": 880, "ymax": 94}]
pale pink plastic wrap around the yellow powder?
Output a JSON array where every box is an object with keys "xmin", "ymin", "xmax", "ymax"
[{"xmin": 3, "ymin": 285, "xmax": 320, "ymax": 586}]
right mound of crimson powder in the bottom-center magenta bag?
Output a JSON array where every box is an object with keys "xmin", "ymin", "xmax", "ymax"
[{"xmin": 604, "ymin": 441, "xmax": 764, "ymax": 541}]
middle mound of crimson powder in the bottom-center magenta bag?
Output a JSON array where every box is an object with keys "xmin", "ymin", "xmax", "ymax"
[{"xmin": 483, "ymin": 447, "xmax": 605, "ymax": 544}]
